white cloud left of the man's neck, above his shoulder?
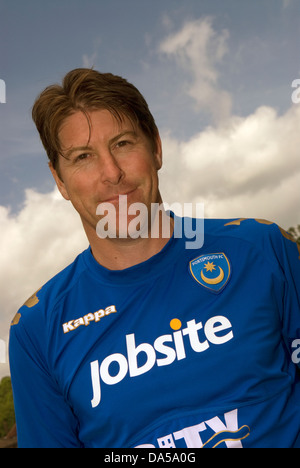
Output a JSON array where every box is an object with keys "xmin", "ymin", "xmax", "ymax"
[{"xmin": 0, "ymin": 189, "xmax": 88, "ymax": 374}]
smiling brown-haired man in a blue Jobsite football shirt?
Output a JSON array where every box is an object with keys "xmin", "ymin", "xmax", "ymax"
[{"xmin": 10, "ymin": 69, "xmax": 300, "ymax": 448}]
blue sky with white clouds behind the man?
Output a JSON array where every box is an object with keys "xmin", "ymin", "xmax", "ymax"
[{"xmin": 0, "ymin": 0, "xmax": 300, "ymax": 378}]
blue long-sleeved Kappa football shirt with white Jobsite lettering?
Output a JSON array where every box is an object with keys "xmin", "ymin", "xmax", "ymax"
[{"xmin": 10, "ymin": 219, "xmax": 300, "ymax": 448}]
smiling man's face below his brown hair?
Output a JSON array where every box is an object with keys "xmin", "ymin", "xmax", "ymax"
[{"xmin": 50, "ymin": 110, "xmax": 162, "ymax": 238}]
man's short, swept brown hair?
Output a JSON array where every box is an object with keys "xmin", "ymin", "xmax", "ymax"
[{"xmin": 32, "ymin": 68, "xmax": 158, "ymax": 169}]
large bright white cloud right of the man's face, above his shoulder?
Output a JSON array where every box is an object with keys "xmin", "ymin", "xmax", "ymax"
[{"xmin": 161, "ymin": 102, "xmax": 300, "ymax": 229}]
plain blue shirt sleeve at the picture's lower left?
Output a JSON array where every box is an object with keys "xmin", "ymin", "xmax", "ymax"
[{"xmin": 9, "ymin": 308, "xmax": 81, "ymax": 448}]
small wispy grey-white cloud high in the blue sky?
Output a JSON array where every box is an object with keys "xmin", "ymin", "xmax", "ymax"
[{"xmin": 159, "ymin": 17, "xmax": 232, "ymax": 122}]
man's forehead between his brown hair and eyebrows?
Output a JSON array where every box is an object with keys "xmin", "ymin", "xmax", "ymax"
[{"xmin": 58, "ymin": 109, "xmax": 138, "ymax": 147}]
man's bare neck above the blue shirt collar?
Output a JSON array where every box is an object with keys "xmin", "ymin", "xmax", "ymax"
[{"xmin": 85, "ymin": 207, "xmax": 174, "ymax": 270}]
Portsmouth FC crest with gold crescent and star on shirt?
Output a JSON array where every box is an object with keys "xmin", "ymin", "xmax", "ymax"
[{"xmin": 189, "ymin": 253, "xmax": 231, "ymax": 293}]
